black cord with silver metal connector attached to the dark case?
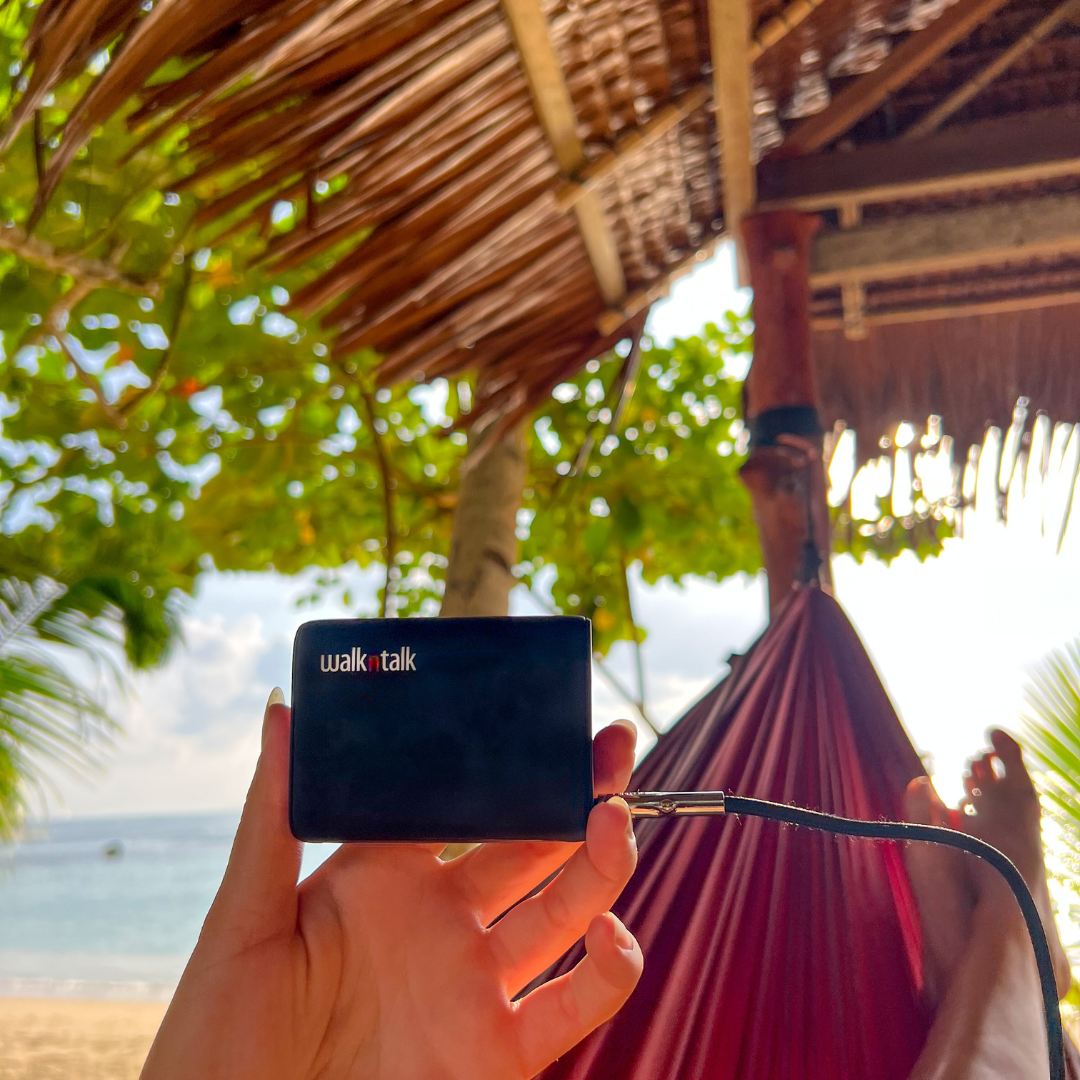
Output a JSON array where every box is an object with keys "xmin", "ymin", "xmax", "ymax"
[{"xmin": 597, "ymin": 792, "xmax": 1065, "ymax": 1080}]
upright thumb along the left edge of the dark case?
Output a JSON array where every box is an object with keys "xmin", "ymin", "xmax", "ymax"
[{"xmin": 206, "ymin": 687, "xmax": 301, "ymax": 948}]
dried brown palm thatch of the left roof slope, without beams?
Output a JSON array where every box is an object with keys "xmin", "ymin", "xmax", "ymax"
[{"xmin": 0, "ymin": 0, "xmax": 723, "ymax": 418}]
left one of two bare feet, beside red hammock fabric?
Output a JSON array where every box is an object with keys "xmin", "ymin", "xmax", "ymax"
[{"xmin": 904, "ymin": 777, "xmax": 976, "ymax": 1011}]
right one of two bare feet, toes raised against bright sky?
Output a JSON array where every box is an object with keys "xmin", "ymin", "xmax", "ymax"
[{"xmin": 960, "ymin": 729, "xmax": 1072, "ymax": 997}]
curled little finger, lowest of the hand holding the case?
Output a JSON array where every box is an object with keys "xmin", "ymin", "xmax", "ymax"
[{"xmin": 516, "ymin": 912, "xmax": 644, "ymax": 1076}]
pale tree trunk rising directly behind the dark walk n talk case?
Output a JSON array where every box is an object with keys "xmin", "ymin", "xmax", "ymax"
[{"xmin": 440, "ymin": 419, "xmax": 526, "ymax": 617}]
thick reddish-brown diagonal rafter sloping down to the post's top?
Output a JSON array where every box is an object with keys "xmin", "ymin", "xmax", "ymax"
[{"xmin": 779, "ymin": 0, "xmax": 1007, "ymax": 156}]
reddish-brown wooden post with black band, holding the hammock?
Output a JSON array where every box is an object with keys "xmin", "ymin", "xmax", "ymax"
[{"xmin": 741, "ymin": 211, "xmax": 833, "ymax": 613}]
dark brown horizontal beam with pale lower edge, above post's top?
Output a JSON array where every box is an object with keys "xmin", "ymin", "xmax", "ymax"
[{"xmin": 758, "ymin": 107, "xmax": 1080, "ymax": 212}]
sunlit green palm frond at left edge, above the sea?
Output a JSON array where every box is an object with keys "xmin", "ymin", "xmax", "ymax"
[{"xmin": 0, "ymin": 578, "xmax": 122, "ymax": 837}]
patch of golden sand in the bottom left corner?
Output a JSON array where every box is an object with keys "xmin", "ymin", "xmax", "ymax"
[{"xmin": 0, "ymin": 998, "xmax": 167, "ymax": 1080}]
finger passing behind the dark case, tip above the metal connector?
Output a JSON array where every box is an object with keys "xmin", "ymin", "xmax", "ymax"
[{"xmin": 450, "ymin": 720, "xmax": 637, "ymax": 926}]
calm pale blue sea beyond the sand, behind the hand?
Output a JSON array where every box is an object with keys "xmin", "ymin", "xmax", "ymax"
[{"xmin": 0, "ymin": 812, "xmax": 333, "ymax": 1000}]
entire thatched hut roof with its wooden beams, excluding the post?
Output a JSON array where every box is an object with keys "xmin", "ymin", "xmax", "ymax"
[{"xmin": 12, "ymin": 0, "xmax": 1080, "ymax": 481}]
